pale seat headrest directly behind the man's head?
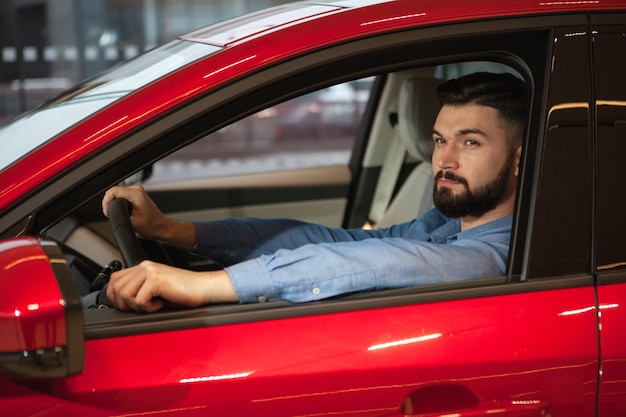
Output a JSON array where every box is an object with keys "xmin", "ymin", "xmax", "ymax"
[{"xmin": 398, "ymin": 75, "xmax": 443, "ymax": 162}]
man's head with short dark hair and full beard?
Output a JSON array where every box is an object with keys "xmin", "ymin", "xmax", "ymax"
[{"xmin": 432, "ymin": 104, "xmax": 519, "ymax": 218}]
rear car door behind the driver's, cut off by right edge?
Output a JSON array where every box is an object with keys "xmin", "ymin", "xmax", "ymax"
[{"xmin": 592, "ymin": 14, "xmax": 626, "ymax": 416}]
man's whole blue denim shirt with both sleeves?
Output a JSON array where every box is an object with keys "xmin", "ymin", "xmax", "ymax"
[{"xmin": 194, "ymin": 209, "xmax": 512, "ymax": 303}]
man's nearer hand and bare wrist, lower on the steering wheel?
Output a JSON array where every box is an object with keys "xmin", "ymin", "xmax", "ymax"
[{"xmin": 106, "ymin": 261, "xmax": 239, "ymax": 313}]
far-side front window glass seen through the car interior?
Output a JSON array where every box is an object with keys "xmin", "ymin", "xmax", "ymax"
[{"xmin": 149, "ymin": 78, "xmax": 373, "ymax": 184}]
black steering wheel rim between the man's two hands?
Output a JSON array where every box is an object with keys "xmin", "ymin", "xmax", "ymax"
[{"xmin": 109, "ymin": 198, "xmax": 147, "ymax": 268}]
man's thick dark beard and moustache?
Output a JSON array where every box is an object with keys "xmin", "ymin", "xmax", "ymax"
[{"xmin": 433, "ymin": 153, "xmax": 514, "ymax": 218}]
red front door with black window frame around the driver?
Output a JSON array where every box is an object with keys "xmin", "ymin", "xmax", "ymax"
[{"xmin": 3, "ymin": 14, "xmax": 599, "ymax": 417}]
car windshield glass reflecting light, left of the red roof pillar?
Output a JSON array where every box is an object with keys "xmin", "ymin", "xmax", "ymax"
[{"xmin": 0, "ymin": 40, "xmax": 220, "ymax": 171}]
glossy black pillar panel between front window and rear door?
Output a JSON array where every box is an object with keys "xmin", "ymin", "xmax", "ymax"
[{"xmin": 529, "ymin": 27, "xmax": 593, "ymax": 278}]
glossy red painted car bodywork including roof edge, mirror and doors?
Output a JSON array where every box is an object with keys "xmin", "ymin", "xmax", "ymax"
[{"xmin": 0, "ymin": 0, "xmax": 626, "ymax": 417}]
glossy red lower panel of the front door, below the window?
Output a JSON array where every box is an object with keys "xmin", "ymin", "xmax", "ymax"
[{"xmin": 0, "ymin": 282, "xmax": 598, "ymax": 417}]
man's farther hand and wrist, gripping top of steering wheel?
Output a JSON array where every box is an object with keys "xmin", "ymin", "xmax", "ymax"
[{"xmin": 102, "ymin": 185, "xmax": 197, "ymax": 250}]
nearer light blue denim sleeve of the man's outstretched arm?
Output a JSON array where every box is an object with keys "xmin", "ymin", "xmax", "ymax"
[{"xmin": 226, "ymin": 234, "xmax": 508, "ymax": 303}]
